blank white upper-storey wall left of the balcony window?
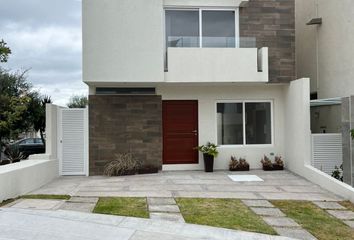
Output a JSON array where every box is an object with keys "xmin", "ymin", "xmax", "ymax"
[{"xmin": 82, "ymin": 0, "xmax": 164, "ymax": 83}]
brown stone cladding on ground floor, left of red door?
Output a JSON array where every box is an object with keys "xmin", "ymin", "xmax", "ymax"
[{"xmin": 89, "ymin": 95, "xmax": 162, "ymax": 175}]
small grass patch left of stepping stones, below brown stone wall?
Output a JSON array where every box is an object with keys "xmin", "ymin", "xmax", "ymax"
[{"xmin": 93, "ymin": 197, "xmax": 149, "ymax": 218}]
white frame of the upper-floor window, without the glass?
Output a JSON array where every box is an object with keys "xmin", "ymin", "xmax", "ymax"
[{"xmin": 163, "ymin": 7, "xmax": 240, "ymax": 51}]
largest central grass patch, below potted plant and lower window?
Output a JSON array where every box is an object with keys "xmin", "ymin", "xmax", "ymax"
[{"xmin": 176, "ymin": 198, "xmax": 276, "ymax": 235}]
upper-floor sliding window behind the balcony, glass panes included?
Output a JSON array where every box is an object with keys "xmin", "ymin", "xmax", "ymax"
[{"xmin": 165, "ymin": 9, "xmax": 238, "ymax": 48}]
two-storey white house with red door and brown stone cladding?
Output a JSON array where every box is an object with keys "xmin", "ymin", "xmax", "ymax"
[{"xmin": 83, "ymin": 0, "xmax": 302, "ymax": 175}]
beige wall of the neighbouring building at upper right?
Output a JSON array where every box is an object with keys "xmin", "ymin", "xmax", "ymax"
[{"xmin": 296, "ymin": 0, "xmax": 354, "ymax": 99}]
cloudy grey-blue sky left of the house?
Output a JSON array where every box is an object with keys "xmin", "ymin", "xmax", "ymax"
[{"xmin": 0, "ymin": 0, "xmax": 88, "ymax": 106}]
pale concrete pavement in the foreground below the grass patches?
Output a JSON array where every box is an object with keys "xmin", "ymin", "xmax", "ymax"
[{"xmin": 0, "ymin": 208, "xmax": 291, "ymax": 240}]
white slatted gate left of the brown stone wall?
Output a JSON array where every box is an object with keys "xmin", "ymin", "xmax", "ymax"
[{"xmin": 58, "ymin": 108, "xmax": 88, "ymax": 176}]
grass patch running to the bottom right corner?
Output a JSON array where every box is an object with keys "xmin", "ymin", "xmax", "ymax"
[{"xmin": 272, "ymin": 201, "xmax": 354, "ymax": 240}]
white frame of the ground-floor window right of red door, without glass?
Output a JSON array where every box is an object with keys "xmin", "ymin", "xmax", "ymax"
[{"xmin": 215, "ymin": 100, "xmax": 274, "ymax": 148}]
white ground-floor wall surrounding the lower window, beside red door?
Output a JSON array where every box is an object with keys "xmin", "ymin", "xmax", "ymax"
[{"xmin": 157, "ymin": 84, "xmax": 284, "ymax": 170}]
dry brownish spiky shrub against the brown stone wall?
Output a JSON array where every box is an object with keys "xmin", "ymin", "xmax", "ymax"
[{"xmin": 104, "ymin": 153, "xmax": 140, "ymax": 176}]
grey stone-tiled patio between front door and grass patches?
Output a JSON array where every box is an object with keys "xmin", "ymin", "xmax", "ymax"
[{"xmin": 32, "ymin": 170, "xmax": 342, "ymax": 201}]
